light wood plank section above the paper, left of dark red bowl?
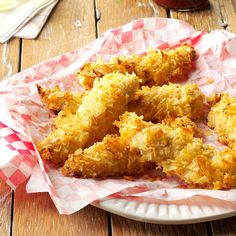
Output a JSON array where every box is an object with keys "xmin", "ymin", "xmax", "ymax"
[{"xmin": 96, "ymin": 0, "xmax": 167, "ymax": 34}]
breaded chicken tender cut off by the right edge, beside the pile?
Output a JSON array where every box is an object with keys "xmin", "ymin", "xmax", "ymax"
[{"xmin": 208, "ymin": 94, "xmax": 236, "ymax": 148}]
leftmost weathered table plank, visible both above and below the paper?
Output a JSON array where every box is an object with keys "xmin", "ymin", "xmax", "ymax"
[{"xmin": 0, "ymin": 39, "xmax": 19, "ymax": 235}]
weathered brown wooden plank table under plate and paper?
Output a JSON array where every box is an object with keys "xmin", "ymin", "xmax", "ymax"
[{"xmin": 0, "ymin": 0, "xmax": 236, "ymax": 236}]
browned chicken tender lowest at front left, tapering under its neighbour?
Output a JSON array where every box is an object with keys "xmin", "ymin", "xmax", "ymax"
[{"xmin": 62, "ymin": 135, "xmax": 155, "ymax": 178}]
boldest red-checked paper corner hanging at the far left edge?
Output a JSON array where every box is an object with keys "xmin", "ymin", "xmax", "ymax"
[{"xmin": 0, "ymin": 122, "xmax": 37, "ymax": 189}]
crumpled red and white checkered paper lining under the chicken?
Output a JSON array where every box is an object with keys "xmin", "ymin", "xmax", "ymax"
[{"xmin": 0, "ymin": 18, "xmax": 236, "ymax": 214}]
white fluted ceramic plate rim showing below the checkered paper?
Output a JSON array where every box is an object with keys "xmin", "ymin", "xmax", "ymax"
[{"xmin": 95, "ymin": 196, "xmax": 236, "ymax": 224}]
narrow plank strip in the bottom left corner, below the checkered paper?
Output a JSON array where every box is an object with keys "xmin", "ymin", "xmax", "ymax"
[{"xmin": 0, "ymin": 179, "xmax": 12, "ymax": 236}]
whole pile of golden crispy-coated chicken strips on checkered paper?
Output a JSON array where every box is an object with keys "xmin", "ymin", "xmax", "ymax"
[{"xmin": 37, "ymin": 45, "xmax": 236, "ymax": 189}]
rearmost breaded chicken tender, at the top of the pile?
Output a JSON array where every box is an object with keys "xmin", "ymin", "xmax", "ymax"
[{"xmin": 76, "ymin": 45, "xmax": 195, "ymax": 89}]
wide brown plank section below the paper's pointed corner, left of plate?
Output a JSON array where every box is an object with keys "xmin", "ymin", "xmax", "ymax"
[{"xmin": 13, "ymin": 184, "xmax": 108, "ymax": 236}]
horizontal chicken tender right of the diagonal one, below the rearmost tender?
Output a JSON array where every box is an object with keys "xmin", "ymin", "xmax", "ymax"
[{"xmin": 129, "ymin": 84, "xmax": 206, "ymax": 122}]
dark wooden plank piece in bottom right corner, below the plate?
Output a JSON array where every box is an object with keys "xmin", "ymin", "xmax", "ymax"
[{"xmin": 211, "ymin": 216, "xmax": 236, "ymax": 236}]
